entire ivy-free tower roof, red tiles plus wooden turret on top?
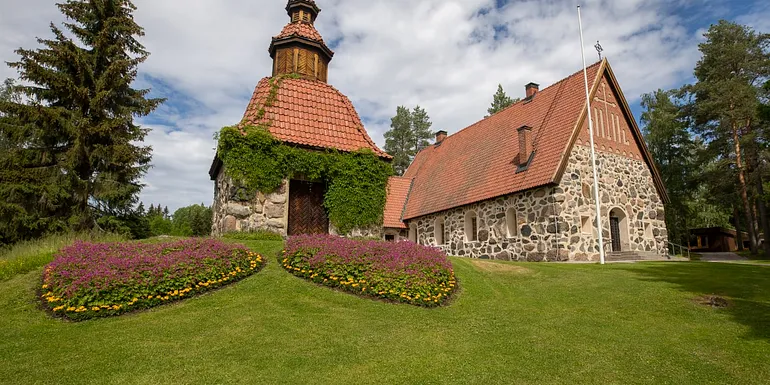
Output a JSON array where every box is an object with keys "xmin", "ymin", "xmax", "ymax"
[{"xmin": 209, "ymin": 0, "xmax": 391, "ymax": 180}]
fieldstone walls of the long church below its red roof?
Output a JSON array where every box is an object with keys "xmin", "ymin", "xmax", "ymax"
[{"xmin": 408, "ymin": 145, "xmax": 667, "ymax": 261}]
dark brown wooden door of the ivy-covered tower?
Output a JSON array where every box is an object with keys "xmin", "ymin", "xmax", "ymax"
[{"xmin": 289, "ymin": 180, "xmax": 329, "ymax": 235}]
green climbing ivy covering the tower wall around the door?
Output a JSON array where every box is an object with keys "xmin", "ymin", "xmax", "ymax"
[{"xmin": 218, "ymin": 77, "xmax": 393, "ymax": 233}]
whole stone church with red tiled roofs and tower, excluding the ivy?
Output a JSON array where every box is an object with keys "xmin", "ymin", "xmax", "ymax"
[{"xmin": 209, "ymin": 0, "xmax": 668, "ymax": 261}]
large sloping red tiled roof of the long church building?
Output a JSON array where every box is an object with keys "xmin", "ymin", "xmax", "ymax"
[{"xmin": 403, "ymin": 58, "xmax": 603, "ymax": 219}]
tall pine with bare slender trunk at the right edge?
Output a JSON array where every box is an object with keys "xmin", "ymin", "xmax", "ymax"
[{"xmin": 691, "ymin": 21, "xmax": 770, "ymax": 253}]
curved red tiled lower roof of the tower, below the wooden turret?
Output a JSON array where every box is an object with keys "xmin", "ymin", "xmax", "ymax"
[{"xmin": 244, "ymin": 78, "xmax": 391, "ymax": 158}]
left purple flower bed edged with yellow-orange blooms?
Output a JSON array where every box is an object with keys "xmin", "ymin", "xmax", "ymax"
[{"xmin": 41, "ymin": 239, "xmax": 265, "ymax": 320}]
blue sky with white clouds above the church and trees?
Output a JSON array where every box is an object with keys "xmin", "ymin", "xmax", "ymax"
[{"xmin": 0, "ymin": 0, "xmax": 770, "ymax": 212}]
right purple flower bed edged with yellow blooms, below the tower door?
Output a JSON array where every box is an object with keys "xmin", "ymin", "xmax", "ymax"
[{"xmin": 280, "ymin": 235, "xmax": 457, "ymax": 306}]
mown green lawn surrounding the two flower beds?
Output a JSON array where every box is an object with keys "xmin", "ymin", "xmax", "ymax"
[{"xmin": 0, "ymin": 238, "xmax": 770, "ymax": 384}]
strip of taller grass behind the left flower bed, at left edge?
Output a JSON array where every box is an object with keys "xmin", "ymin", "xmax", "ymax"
[{"xmin": 0, "ymin": 233, "xmax": 125, "ymax": 282}]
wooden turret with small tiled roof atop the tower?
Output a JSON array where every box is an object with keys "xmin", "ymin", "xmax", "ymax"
[{"xmin": 269, "ymin": 0, "xmax": 334, "ymax": 83}]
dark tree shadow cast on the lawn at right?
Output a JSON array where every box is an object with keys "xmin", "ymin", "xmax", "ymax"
[{"xmin": 624, "ymin": 262, "xmax": 770, "ymax": 339}]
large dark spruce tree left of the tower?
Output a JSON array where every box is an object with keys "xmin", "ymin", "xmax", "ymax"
[{"xmin": 0, "ymin": 0, "xmax": 162, "ymax": 236}]
